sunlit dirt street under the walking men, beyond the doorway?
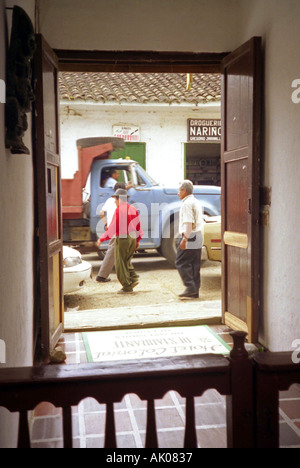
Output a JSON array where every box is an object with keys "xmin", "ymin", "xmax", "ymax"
[{"xmin": 65, "ymin": 251, "xmax": 221, "ymax": 311}]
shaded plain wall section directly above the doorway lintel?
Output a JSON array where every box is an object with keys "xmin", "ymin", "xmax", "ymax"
[{"xmin": 40, "ymin": 0, "xmax": 240, "ymax": 52}]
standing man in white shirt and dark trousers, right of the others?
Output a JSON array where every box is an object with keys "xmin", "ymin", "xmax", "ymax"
[{"xmin": 175, "ymin": 180, "xmax": 204, "ymax": 299}]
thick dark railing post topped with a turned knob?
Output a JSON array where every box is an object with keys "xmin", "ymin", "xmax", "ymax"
[{"xmin": 227, "ymin": 331, "xmax": 254, "ymax": 448}]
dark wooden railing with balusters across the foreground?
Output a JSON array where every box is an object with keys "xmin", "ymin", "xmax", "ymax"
[{"xmin": 0, "ymin": 332, "xmax": 300, "ymax": 448}]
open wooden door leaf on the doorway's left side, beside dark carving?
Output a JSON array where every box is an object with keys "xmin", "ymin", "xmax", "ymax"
[{"xmin": 33, "ymin": 35, "xmax": 63, "ymax": 360}]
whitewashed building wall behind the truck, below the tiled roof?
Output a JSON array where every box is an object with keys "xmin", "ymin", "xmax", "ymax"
[{"xmin": 60, "ymin": 101, "xmax": 220, "ymax": 187}]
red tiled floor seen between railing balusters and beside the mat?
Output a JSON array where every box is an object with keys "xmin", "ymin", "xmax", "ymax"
[{"xmin": 31, "ymin": 326, "xmax": 300, "ymax": 448}]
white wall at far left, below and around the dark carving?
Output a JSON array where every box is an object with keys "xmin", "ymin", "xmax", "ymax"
[{"xmin": 0, "ymin": 1, "xmax": 34, "ymax": 447}]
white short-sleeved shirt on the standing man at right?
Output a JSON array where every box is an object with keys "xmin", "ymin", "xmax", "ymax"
[{"xmin": 179, "ymin": 194, "xmax": 204, "ymax": 234}]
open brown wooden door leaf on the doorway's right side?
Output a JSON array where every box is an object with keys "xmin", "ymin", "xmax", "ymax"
[{"xmin": 221, "ymin": 37, "xmax": 262, "ymax": 342}]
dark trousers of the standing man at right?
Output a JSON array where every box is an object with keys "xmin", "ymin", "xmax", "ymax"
[{"xmin": 175, "ymin": 234, "xmax": 202, "ymax": 293}]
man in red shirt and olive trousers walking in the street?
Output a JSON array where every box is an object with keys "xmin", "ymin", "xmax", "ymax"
[{"xmin": 97, "ymin": 189, "xmax": 144, "ymax": 293}]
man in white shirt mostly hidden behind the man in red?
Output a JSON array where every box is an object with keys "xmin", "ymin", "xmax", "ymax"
[{"xmin": 96, "ymin": 182, "xmax": 125, "ymax": 283}]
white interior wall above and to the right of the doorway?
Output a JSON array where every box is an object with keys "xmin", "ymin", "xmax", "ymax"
[{"xmin": 40, "ymin": 0, "xmax": 300, "ymax": 350}]
